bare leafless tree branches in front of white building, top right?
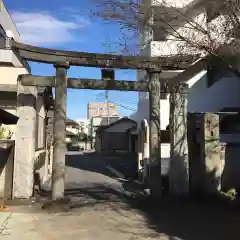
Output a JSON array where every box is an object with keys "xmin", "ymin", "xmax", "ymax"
[{"xmin": 91, "ymin": 0, "xmax": 240, "ymax": 73}]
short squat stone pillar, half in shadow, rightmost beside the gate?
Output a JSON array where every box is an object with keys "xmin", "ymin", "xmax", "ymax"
[{"xmin": 188, "ymin": 113, "xmax": 225, "ymax": 195}]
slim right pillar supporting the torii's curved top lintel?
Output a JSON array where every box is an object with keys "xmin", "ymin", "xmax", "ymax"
[{"xmin": 149, "ymin": 70, "xmax": 162, "ymax": 197}]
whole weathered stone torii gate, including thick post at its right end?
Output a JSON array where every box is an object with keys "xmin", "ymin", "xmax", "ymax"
[{"xmin": 11, "ymin": 41, "xmax": 196, "ymax": 201}]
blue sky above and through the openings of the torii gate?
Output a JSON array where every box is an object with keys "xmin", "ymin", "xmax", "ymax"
[{"xmin": 4, "ymin": 0, "xmax": 138, "ymax": 119}]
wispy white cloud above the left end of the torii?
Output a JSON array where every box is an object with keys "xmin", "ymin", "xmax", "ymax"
[{"xmin": 11, "ymin": 11, "xmax": 89, "ymax": 46}]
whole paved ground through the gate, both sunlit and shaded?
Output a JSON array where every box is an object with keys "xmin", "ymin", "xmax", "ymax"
[{"xmin": 0, "ymin": 155, "xmax": 240, "ymax": 240}]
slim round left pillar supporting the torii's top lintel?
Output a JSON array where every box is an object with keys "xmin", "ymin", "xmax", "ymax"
[{"xmin": 52, "ymin": 63, "xmax": 69, "ymax": 201}]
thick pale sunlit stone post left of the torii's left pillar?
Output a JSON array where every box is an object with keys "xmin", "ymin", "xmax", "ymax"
[{"xmin": 12, "ymin": 80, "xmax": 37, "ymax": 199}]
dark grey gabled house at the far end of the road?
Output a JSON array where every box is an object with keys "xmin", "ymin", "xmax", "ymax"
[{"xmin": 95, "ymin": 117, "xmax": 137, "ymax": 152}]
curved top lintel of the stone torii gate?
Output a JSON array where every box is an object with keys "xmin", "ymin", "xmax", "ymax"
[{"xmin": 11, "ymin": 40, "xmax": 199, "ymax": 71}]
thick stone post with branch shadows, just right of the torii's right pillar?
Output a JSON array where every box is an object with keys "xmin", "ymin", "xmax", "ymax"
[{"xmin": 169, "ymin": 83, "xmax": 189, "ymax": 195}]
